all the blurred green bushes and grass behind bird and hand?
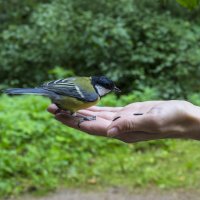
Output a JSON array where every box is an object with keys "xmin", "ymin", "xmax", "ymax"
[{"xmin": 0, "ymin": 0, "xmax": 200, "ymax": 197}]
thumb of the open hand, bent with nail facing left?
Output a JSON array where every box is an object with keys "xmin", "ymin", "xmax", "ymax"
[{"xmin": 107, "ymin": 115, "xmax": 153, "ymax": 137}]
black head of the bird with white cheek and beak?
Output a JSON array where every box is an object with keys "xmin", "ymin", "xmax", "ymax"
[{"xmin": 92, "ymin": 76, "xmax": 120, "ymax": 96}]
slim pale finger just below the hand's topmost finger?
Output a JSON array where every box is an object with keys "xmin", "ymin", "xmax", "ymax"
[{"xmin": 78, "ymin": 110, "xmax": 115, "ymax": 121}]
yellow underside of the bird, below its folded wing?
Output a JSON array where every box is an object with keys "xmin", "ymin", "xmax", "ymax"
[{"xmin": 55, "ymin": 96, "xmax": 100, "ymax": 113}]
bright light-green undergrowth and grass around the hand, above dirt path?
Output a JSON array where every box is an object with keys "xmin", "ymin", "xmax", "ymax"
[{"xmin": 0, "ymin": 92, "xmax": 200, "ymax": 197}]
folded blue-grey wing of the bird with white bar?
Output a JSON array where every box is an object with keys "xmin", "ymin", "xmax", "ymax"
[{"xmin": 41, "ymin": 78, "xmax": 99, "ymax": 102}]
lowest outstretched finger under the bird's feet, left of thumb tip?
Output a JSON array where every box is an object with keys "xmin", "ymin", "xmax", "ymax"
[{"xmin": 55, "ymin": 114, "xmax": 110, "ymax": 136}]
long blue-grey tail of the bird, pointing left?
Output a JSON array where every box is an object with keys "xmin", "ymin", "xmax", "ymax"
[{"xmin": 3, "ymin": 88, "xmax": 52, "ymax": 96}]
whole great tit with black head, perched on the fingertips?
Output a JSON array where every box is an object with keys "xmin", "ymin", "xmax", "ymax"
[{"xmin": 3, "ymin": 76, "xmax": 120, "ymax": 120}]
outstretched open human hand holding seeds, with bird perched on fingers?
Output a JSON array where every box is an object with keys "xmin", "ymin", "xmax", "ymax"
[{"xmin": 48, "ymin": 100, "xmax": 200, "ymax": 143}]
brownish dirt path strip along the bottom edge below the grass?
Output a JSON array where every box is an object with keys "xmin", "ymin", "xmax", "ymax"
[{"xmin": 13, "ymin": 189, "xmax": 200, "ymax": 200}]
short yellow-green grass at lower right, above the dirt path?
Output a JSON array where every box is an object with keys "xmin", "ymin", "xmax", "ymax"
[{"xmin": 62, "ymin": 140, "xmax": 200, "ymax": 189}]
